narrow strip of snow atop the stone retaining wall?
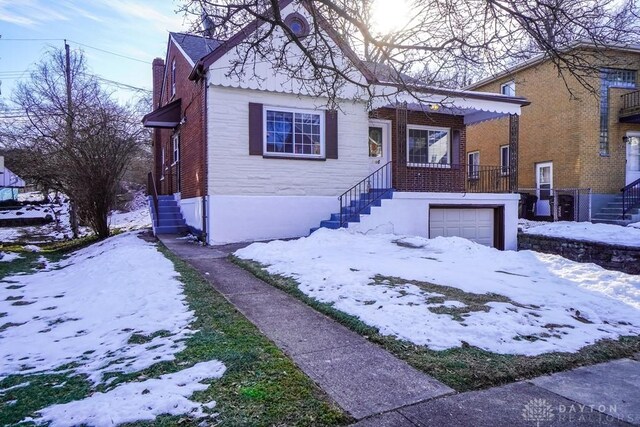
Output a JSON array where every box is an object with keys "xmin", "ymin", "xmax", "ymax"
[{"xmin": 520, "ymin": 220, "xmax": 640, "ymax": 247}]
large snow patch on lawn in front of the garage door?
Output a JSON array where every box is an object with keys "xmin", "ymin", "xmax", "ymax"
[{"xmin": 236, "ymin": 229, "xmax": 640, "ymax": 355}]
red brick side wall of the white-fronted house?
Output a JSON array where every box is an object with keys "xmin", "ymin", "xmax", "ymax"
[{"xmin": 153, "ymin": 40, "xmax": 206, "ymax": 199}]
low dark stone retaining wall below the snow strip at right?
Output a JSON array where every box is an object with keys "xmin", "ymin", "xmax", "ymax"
[{"xmin": 518, "ymin": 233, "xmax": 640, "ymax": 274}]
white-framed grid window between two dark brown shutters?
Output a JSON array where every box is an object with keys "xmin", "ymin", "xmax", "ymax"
[{"xmin": 264, "ymin": 107, "xmax": 324, "ymax": 157}]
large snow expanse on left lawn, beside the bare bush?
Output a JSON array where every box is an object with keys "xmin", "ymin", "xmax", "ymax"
[{"xmin": 0, "ymin": 233, "xmax": 193, "ymax": 383}]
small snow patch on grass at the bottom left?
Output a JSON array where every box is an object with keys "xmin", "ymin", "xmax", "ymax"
[{"xmin": 29, "ymin": 360, "xmax": 225, "ymax": 427}]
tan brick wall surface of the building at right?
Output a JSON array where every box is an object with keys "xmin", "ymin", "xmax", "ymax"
[{"xmin": 467, "ymin": 52, "xmax": 640, "ymax": 194}]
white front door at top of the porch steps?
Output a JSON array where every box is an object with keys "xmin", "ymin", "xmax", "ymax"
[{"xmin": 368, "ymin": 120, "xmax": 391, "ymax": 188}]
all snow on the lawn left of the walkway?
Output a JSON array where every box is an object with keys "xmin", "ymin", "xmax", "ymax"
[{"xmin": 0, "ymin": 233, "xmax": 225, "ymax": 425}]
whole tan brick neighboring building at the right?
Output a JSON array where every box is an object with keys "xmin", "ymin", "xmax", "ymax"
[{"xmin": 466, "ymin": 45, "xmax": 640, "ymax": 223}]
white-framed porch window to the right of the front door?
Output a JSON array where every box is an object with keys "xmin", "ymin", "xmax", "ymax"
[{"xmin": 407, "ymin": 126, "xmax": 451, "ymax": 166}]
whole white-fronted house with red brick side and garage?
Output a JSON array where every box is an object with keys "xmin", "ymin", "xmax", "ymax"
[{"xmin": 143, "ymin": 0, "xmax": 527, "ymax": 249}]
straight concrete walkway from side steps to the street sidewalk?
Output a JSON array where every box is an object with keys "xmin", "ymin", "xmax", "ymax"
[{"xmin": 159, "ymin": 235, "xmax": 454, "ymax": 420}]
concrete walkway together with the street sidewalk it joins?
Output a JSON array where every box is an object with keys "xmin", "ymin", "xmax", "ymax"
[{"xmin": 159, "ymin": 235, "xmax": 640, "ymax": 427}]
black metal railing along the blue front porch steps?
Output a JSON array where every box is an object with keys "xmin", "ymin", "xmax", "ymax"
[{"xmin": 338, "ymin": 161, "xmax": 393, "ymax": 227}]
